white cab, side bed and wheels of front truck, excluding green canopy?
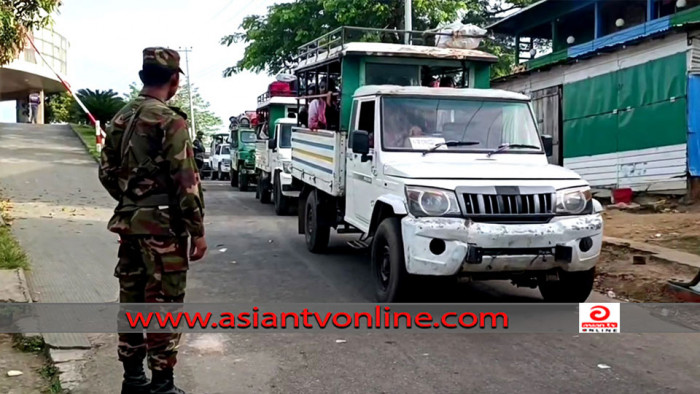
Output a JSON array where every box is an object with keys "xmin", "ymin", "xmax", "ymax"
[{"xmin": 292, "ymin": 86, "xmax": 603, "ymax": 302}]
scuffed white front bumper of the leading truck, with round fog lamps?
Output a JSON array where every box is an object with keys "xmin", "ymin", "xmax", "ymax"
[{"xmin": 401, "ymin": 214, "xmax": 603, "ymax": 276}]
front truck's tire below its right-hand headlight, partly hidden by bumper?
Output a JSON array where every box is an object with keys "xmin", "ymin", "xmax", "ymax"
[{"xmin": 539, "ymin": 268, "xmax": 595, "ymax": 303}]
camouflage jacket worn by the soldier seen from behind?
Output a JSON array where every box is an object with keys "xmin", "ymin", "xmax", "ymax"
[{"xmin": 99, "ymin": 96, "xmax": 204, "ymax": 237}]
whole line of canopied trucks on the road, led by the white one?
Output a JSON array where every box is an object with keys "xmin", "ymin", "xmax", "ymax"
[{"xmin": 216, "ymin": 28, "xmax": 603, "ymax": 302}]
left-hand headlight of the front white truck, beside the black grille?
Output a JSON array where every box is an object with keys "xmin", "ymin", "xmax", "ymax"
[{"xmin": 406, "ymin": 186, "xmax": 462, "ymax": 217}]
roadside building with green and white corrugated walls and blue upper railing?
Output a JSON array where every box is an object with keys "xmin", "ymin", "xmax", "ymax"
[{"xmin": 490, "ymin": 0, "xmax": 700, "ymax": 195}]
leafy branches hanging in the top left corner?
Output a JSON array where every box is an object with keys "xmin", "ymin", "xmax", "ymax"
[{"xmin": 0, "ymin": 0, "xmax": 61, "ymax": 66}]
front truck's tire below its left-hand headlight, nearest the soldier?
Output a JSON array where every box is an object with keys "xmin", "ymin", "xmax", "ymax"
[{"xmin": 371, "ymin": 218, "xmax": 411, "ymax": 302}]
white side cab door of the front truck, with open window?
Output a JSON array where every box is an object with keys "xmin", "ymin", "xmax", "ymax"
[{"xmin": 345, "ymin": 98, "xmax": 379, "ymax": 232}]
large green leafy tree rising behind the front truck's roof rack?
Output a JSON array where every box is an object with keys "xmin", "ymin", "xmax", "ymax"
[{"xmin": 221, "ymin": 0, "xmax": 535, "ymax": 76}]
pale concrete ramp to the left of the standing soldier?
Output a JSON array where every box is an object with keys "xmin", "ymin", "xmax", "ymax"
[{"xmin": 0, "ymin": 124, "xmax": 118, "ymax": 348}]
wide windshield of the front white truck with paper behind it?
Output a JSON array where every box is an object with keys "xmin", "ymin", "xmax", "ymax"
[{"xmin": 382, "ymin": 97, "xmax": 541, "ymax": 152}]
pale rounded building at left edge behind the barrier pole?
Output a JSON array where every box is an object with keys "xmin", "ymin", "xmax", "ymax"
[{"xmin": 0, "ymin": 30, "xmax": 69, "ymax": 124}]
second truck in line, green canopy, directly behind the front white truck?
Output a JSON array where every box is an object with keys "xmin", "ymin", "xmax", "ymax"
[{"xmin": 255, "ymin": 92, "xmax": 299, "ymax": 215}]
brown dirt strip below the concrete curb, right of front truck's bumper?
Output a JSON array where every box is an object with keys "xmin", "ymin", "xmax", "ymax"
[{"xmin": 595, "ymin": 245, "xmax": 698, "ymax": 302}]
